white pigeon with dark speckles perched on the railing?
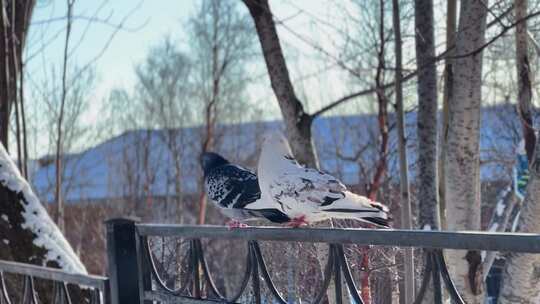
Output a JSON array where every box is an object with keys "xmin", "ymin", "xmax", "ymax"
[{"xmin": 254, "ymin": 132, "xmax": 389, "ymax": 228}]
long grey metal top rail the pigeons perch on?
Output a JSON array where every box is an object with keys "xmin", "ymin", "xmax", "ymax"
[{"xmin": 136, "ymin": 224, "xmax": 540, "ymax": 253}]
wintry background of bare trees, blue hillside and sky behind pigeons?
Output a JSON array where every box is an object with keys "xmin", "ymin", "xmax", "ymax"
[{"xmin": 0, "ymin": 0, "xmax": 540, "ymax": 303}]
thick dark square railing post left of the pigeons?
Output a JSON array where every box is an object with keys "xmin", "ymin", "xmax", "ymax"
[{"xmin": 105, "ymin": 218, "xmax": 144, "ymax": 304}]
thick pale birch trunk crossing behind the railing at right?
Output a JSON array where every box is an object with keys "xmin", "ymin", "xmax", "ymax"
[{"xmin": 445, "ymin": 0, "xmax": 488, "ymax": 304}]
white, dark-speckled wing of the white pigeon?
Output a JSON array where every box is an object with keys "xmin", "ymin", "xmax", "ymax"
[{"xmin": 269, "ymin": 166, "xmax": 347, "ymax": 208}]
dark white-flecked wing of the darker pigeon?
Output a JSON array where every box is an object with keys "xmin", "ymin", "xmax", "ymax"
[{"xmin": 205, "ymin": 165, "xmax": 261, "ymax": 208}]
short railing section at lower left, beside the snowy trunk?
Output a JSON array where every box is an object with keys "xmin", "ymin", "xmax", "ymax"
[{"xmin": 0, "ymin": 261, "xmax": 110, "ymax": 304}]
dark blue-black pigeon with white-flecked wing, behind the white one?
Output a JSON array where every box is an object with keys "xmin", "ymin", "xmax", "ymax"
[{"xmin": 200, "ymin": 152, "xmax": 290, "ymax": 228}]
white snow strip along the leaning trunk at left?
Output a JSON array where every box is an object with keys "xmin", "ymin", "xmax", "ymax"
[{"xmin": 0, "ymin": 145, "xmax": 87, "ymax": 274}]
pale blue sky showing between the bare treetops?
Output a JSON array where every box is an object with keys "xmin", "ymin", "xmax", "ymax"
[{"xmin": 21, "ymin": 0, "xmax": 410, "ymax": 157}]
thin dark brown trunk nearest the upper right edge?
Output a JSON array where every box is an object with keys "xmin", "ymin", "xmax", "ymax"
[{"xmin": 514, "ymin": 0, "xmax": 536, "ymax": 164}]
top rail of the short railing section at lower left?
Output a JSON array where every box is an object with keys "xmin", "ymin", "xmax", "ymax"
[{"xmin": 0, "ymin": 261, "xmax": 108, "ymax": 290}]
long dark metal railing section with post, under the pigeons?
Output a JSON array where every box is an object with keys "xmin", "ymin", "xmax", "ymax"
[{"xmin": 107, "ymin": 219, "xmax": 540, "ymax": 304}]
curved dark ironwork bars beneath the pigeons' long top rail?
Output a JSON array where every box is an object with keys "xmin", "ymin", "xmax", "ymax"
[{"xmin": 143, "ymin": 236, "xmax": 465, "ymax": 304}]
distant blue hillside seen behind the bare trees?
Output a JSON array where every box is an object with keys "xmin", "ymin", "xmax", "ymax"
[{"xmin": 32, "ymin": 105, "xmax": 521, "ymax": 203}]
